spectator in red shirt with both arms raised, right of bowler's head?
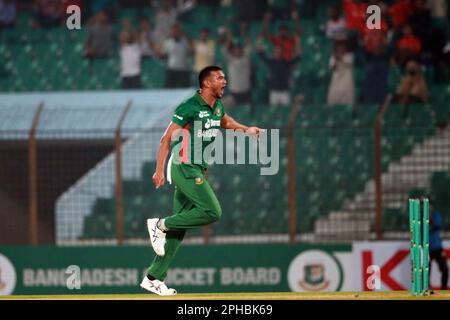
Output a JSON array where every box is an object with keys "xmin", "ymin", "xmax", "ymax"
[{"xmin": 261, "ymin": 10, "xmax": 301, "ymax": 61}]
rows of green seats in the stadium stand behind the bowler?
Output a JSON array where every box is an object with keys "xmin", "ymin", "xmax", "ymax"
[{"xmin": 0, "ymin": 1, "xmax": 450, "ymax": 240}]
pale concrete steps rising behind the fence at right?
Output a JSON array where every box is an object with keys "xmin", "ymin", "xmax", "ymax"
[{"xmin": 314, "ymin": 126, "xmax": 450, "ymax": 241}]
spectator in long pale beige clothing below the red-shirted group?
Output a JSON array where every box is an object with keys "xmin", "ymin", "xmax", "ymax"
[{"xmin": 327, "ymin": 43, "xmax": 355, "ymax": 106}]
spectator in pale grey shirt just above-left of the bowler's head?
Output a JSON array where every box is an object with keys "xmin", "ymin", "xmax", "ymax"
[{"xmin": 158, "ymin": 23, "xmax": 193, "ymax": 88}]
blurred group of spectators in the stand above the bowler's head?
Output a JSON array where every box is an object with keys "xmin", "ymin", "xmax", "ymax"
[{"xmin": 79, "ymin": 0, "xmax": 301, "ymax": 106}]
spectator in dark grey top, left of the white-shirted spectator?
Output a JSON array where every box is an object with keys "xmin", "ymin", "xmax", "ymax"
[{"xmin": 84, "ymin": 11, "xmax": 114, "ymax": 59}]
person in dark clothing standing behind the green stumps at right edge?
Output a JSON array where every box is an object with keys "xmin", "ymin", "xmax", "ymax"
[{"xmin": 429, "ymin": 210, "xmax": 448, "ymax": 290}]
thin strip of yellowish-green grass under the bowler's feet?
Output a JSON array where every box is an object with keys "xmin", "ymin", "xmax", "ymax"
[{"xmin": 0, "ymin": 291, "xmax": 450, "ymax": 300}]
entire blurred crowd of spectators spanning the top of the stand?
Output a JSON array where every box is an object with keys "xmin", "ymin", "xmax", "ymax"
[{"xmin": 0, "ymin": 0, "xmax": 450, "ymax": 106}]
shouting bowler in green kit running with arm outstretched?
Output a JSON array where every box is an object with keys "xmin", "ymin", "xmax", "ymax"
[{"xmin": 141, "ymin": 66, "xmax": 262, "ymax": 296}]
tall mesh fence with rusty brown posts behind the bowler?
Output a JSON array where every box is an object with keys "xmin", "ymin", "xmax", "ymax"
[{"xmin": 0, "ymin": 98, "xmax": 450, "ymax": 245}]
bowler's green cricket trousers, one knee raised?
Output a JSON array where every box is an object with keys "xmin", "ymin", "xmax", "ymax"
[{"xmin": 147, "ymin": 161, "xmax": 222, "ymax": 281}]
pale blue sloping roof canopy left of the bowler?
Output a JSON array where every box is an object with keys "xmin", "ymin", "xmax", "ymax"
[{"xmin": 0, "ymin": 89, "xmax": 193, "ymax": 140}]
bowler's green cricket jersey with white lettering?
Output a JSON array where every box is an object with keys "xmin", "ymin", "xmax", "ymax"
[{"xmin": 172, "ymin": 92, "xmax": 224, "ymax": 168}]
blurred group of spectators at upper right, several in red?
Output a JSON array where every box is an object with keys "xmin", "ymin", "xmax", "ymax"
[{"xmin": 325, "ymin": 0, "xmax": 450, "ymax": 105}]
